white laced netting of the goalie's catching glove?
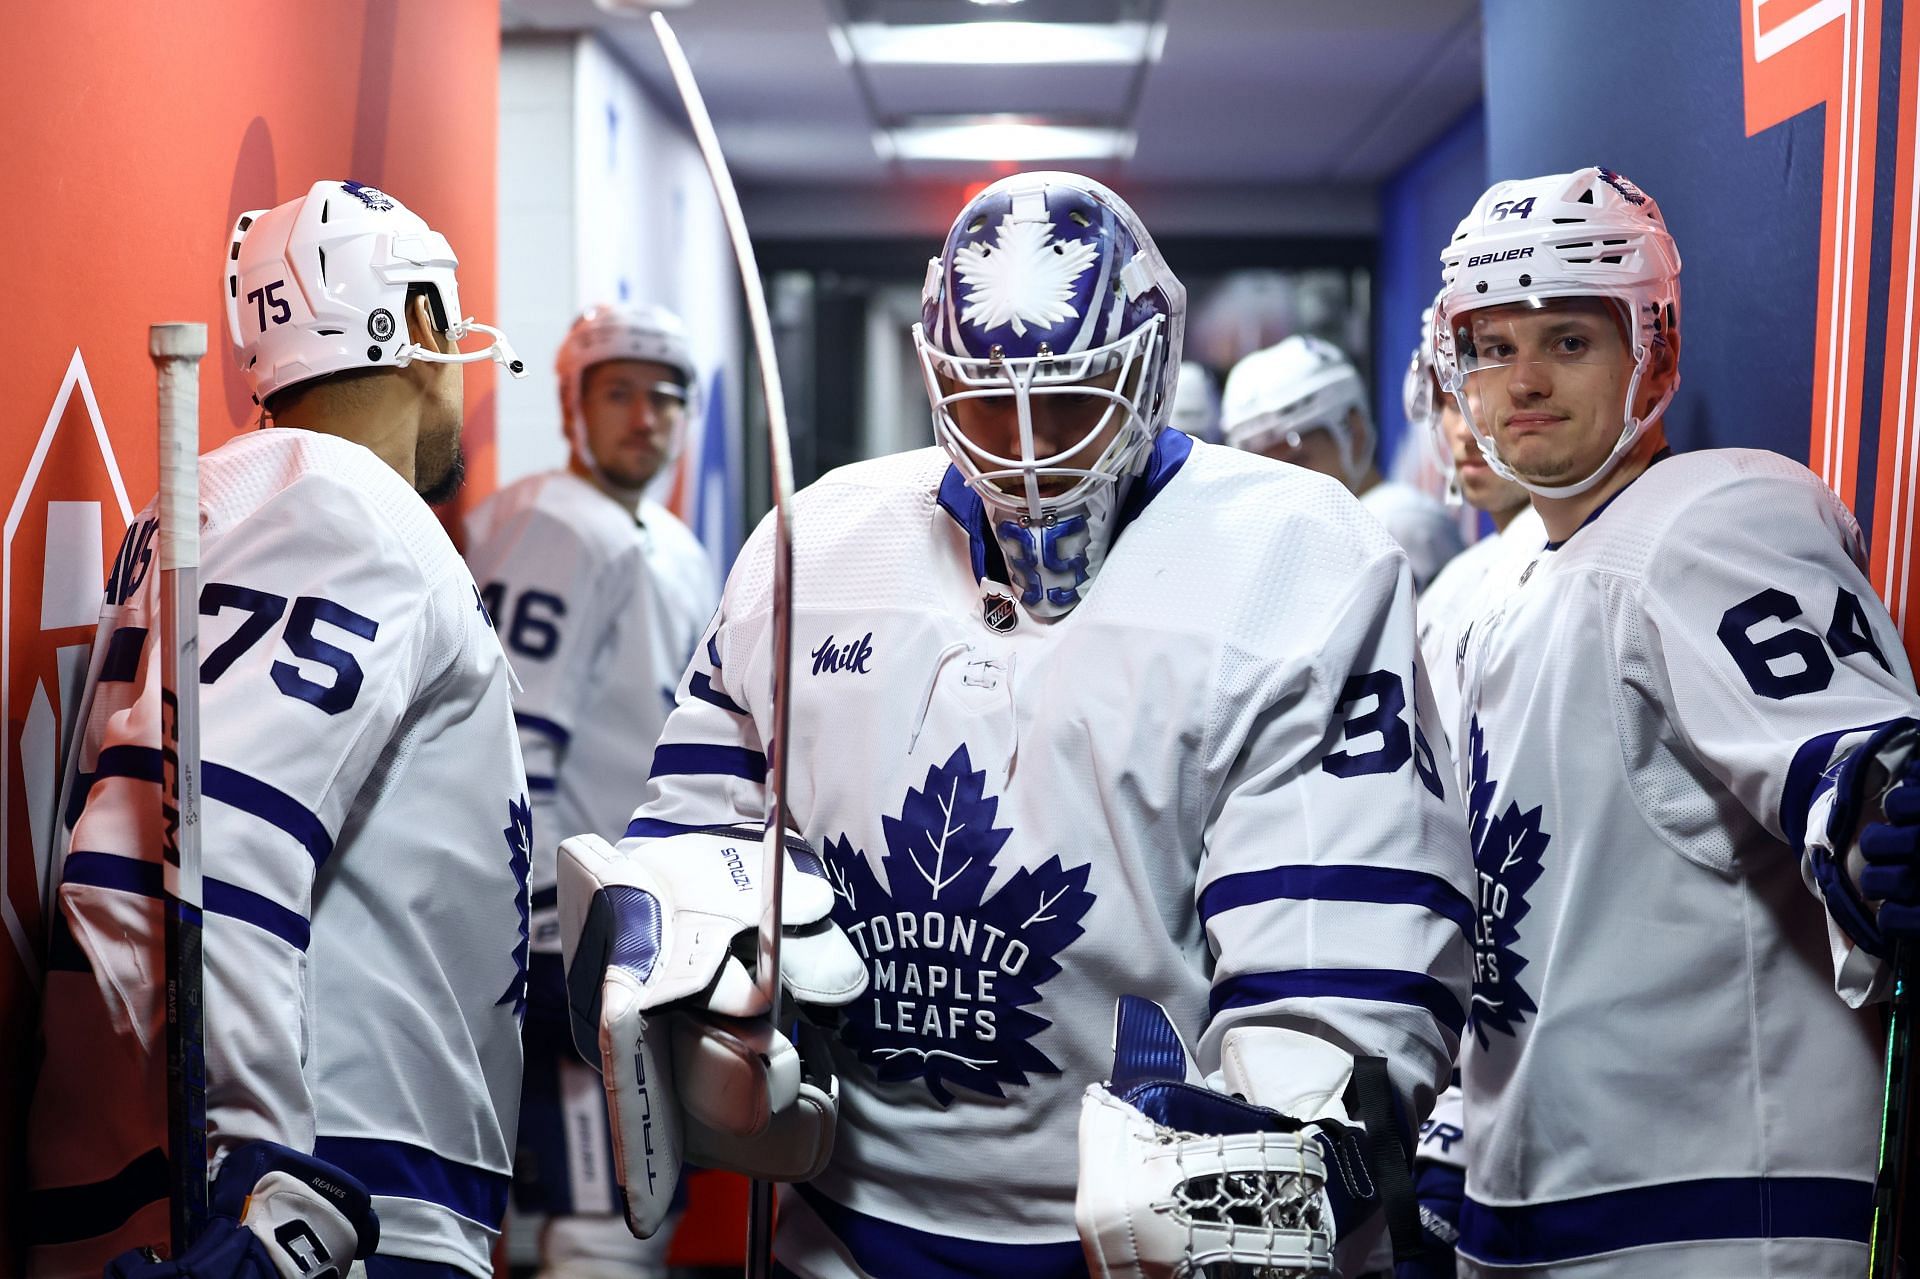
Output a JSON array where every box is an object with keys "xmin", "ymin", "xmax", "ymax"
[{"xmin": 1150, "ymin": 1123, "xmax": 1336, "ymax": 1279}]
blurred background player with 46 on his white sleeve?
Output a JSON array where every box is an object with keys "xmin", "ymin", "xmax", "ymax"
[{"xmin": 467, "ymin": 305, "xmax": 720, "ymax": 1279}]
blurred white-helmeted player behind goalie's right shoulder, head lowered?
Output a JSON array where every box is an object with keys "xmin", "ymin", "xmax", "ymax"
[{"xmin": 1221, "ymin": 334, "xmax": 1461, "ymax": 590}]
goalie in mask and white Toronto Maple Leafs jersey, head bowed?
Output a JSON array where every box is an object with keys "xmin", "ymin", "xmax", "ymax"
[{"xmin": 559, "ymin": 173, "xmax": 1471, "ymax": 1279}]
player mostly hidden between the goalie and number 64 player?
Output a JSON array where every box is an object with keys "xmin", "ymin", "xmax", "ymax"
[{"xmin": 1404, "ymin": 295, "xmax": 1548, "ymax": 749}]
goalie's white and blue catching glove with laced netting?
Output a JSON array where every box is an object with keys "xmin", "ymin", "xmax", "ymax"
[{"xmin": 1073, "ymin": 995, "xmax": 1411, "ymax": 1279}]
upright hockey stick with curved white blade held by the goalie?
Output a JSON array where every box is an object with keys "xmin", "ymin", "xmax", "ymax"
[{"xmin": 653, "ymin": 12, "xmax": 793, "ymax": 1279}]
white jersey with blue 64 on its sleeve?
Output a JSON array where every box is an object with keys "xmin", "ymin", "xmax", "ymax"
[{"xmin": 1455, "ymin": 449, "xmax": 1920, "ymax": 1279}]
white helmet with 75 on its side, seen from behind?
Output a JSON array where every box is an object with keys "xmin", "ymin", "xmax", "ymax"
[{"xmin": 227, "ymin": 181, "xmax": 526, "ymax": 403}]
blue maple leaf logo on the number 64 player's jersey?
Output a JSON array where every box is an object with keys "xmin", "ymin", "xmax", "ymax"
[{"xmin": 1467, "ymin": 716, "xmax": 1549, "ymax": 1049}]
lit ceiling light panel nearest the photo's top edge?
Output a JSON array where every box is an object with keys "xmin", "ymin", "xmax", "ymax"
[{"xmin": 833, "ymin": 21, "xmax": 1165, "ymax": 67}]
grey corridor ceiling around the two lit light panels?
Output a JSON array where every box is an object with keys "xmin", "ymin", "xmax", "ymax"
[{"xmin": 501, "ymin": 0, "xmax": 1480, "ymax": 229}]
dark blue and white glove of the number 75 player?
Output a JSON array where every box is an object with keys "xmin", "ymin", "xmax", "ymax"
[{"xmin": 106, "ymin": 1141, "xmax": 380, "ymax": 1279}]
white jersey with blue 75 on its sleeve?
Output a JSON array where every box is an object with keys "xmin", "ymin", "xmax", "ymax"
[{"xmin": 29, "ymin": 428, "xmax": 528, "ymax": 1277}]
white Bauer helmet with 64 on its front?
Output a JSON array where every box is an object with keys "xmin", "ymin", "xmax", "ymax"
[{"xmin": 1434, "ymin": 167, "xmax": 1680, "ymax": 497}]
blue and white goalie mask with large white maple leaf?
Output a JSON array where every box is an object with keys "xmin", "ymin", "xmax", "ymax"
[{"xmin": 914, "ymin": 173, "xmax": 1187, "ymax": 616}]
